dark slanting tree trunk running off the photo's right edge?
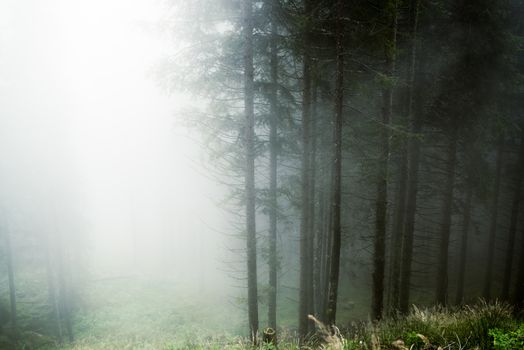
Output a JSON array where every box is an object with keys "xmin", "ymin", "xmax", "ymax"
[{"xmin": 501, "ymin": 128, "xmax": 524, "ymax": 300}]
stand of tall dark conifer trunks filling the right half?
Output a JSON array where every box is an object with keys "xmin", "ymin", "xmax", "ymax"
[{"xmin": 238, "ymin": 0, "xmax": 524, "ymax": 337}]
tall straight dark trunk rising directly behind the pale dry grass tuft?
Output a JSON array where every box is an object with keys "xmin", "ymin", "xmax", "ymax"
[{"xmin": 326, "ymin": 0, "xmax": 344, "ymax": 325}]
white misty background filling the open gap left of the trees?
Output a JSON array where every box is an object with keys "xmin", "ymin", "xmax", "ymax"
[{"xmin": 0, "ymin": 0, "xmax": 227, "ymax": 289}]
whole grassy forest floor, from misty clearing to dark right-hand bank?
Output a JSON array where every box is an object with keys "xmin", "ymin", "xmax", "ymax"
[{"xmin": 53, "ymin": 287, "xmax": 524, "ymax": 350}]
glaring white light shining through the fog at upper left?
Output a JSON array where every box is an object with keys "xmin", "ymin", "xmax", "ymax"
[{"xmin": 0, "ymin": 0, "xmax": 227, "ymax": 284}]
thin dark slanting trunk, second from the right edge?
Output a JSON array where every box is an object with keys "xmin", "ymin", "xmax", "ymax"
[{"xmin": 483, "ymin": 136, "xmax": 504, "ymax": 300}]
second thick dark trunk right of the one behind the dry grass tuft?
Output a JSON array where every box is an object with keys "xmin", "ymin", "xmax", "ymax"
[{"xmin": 398, "ymin": 0, "xmax": 421, "ymax": 313}]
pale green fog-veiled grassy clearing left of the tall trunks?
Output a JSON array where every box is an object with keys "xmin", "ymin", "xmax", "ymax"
[{"xmin": 54, "ymin": 278, "xmax": 249, "ymax": 349}]
